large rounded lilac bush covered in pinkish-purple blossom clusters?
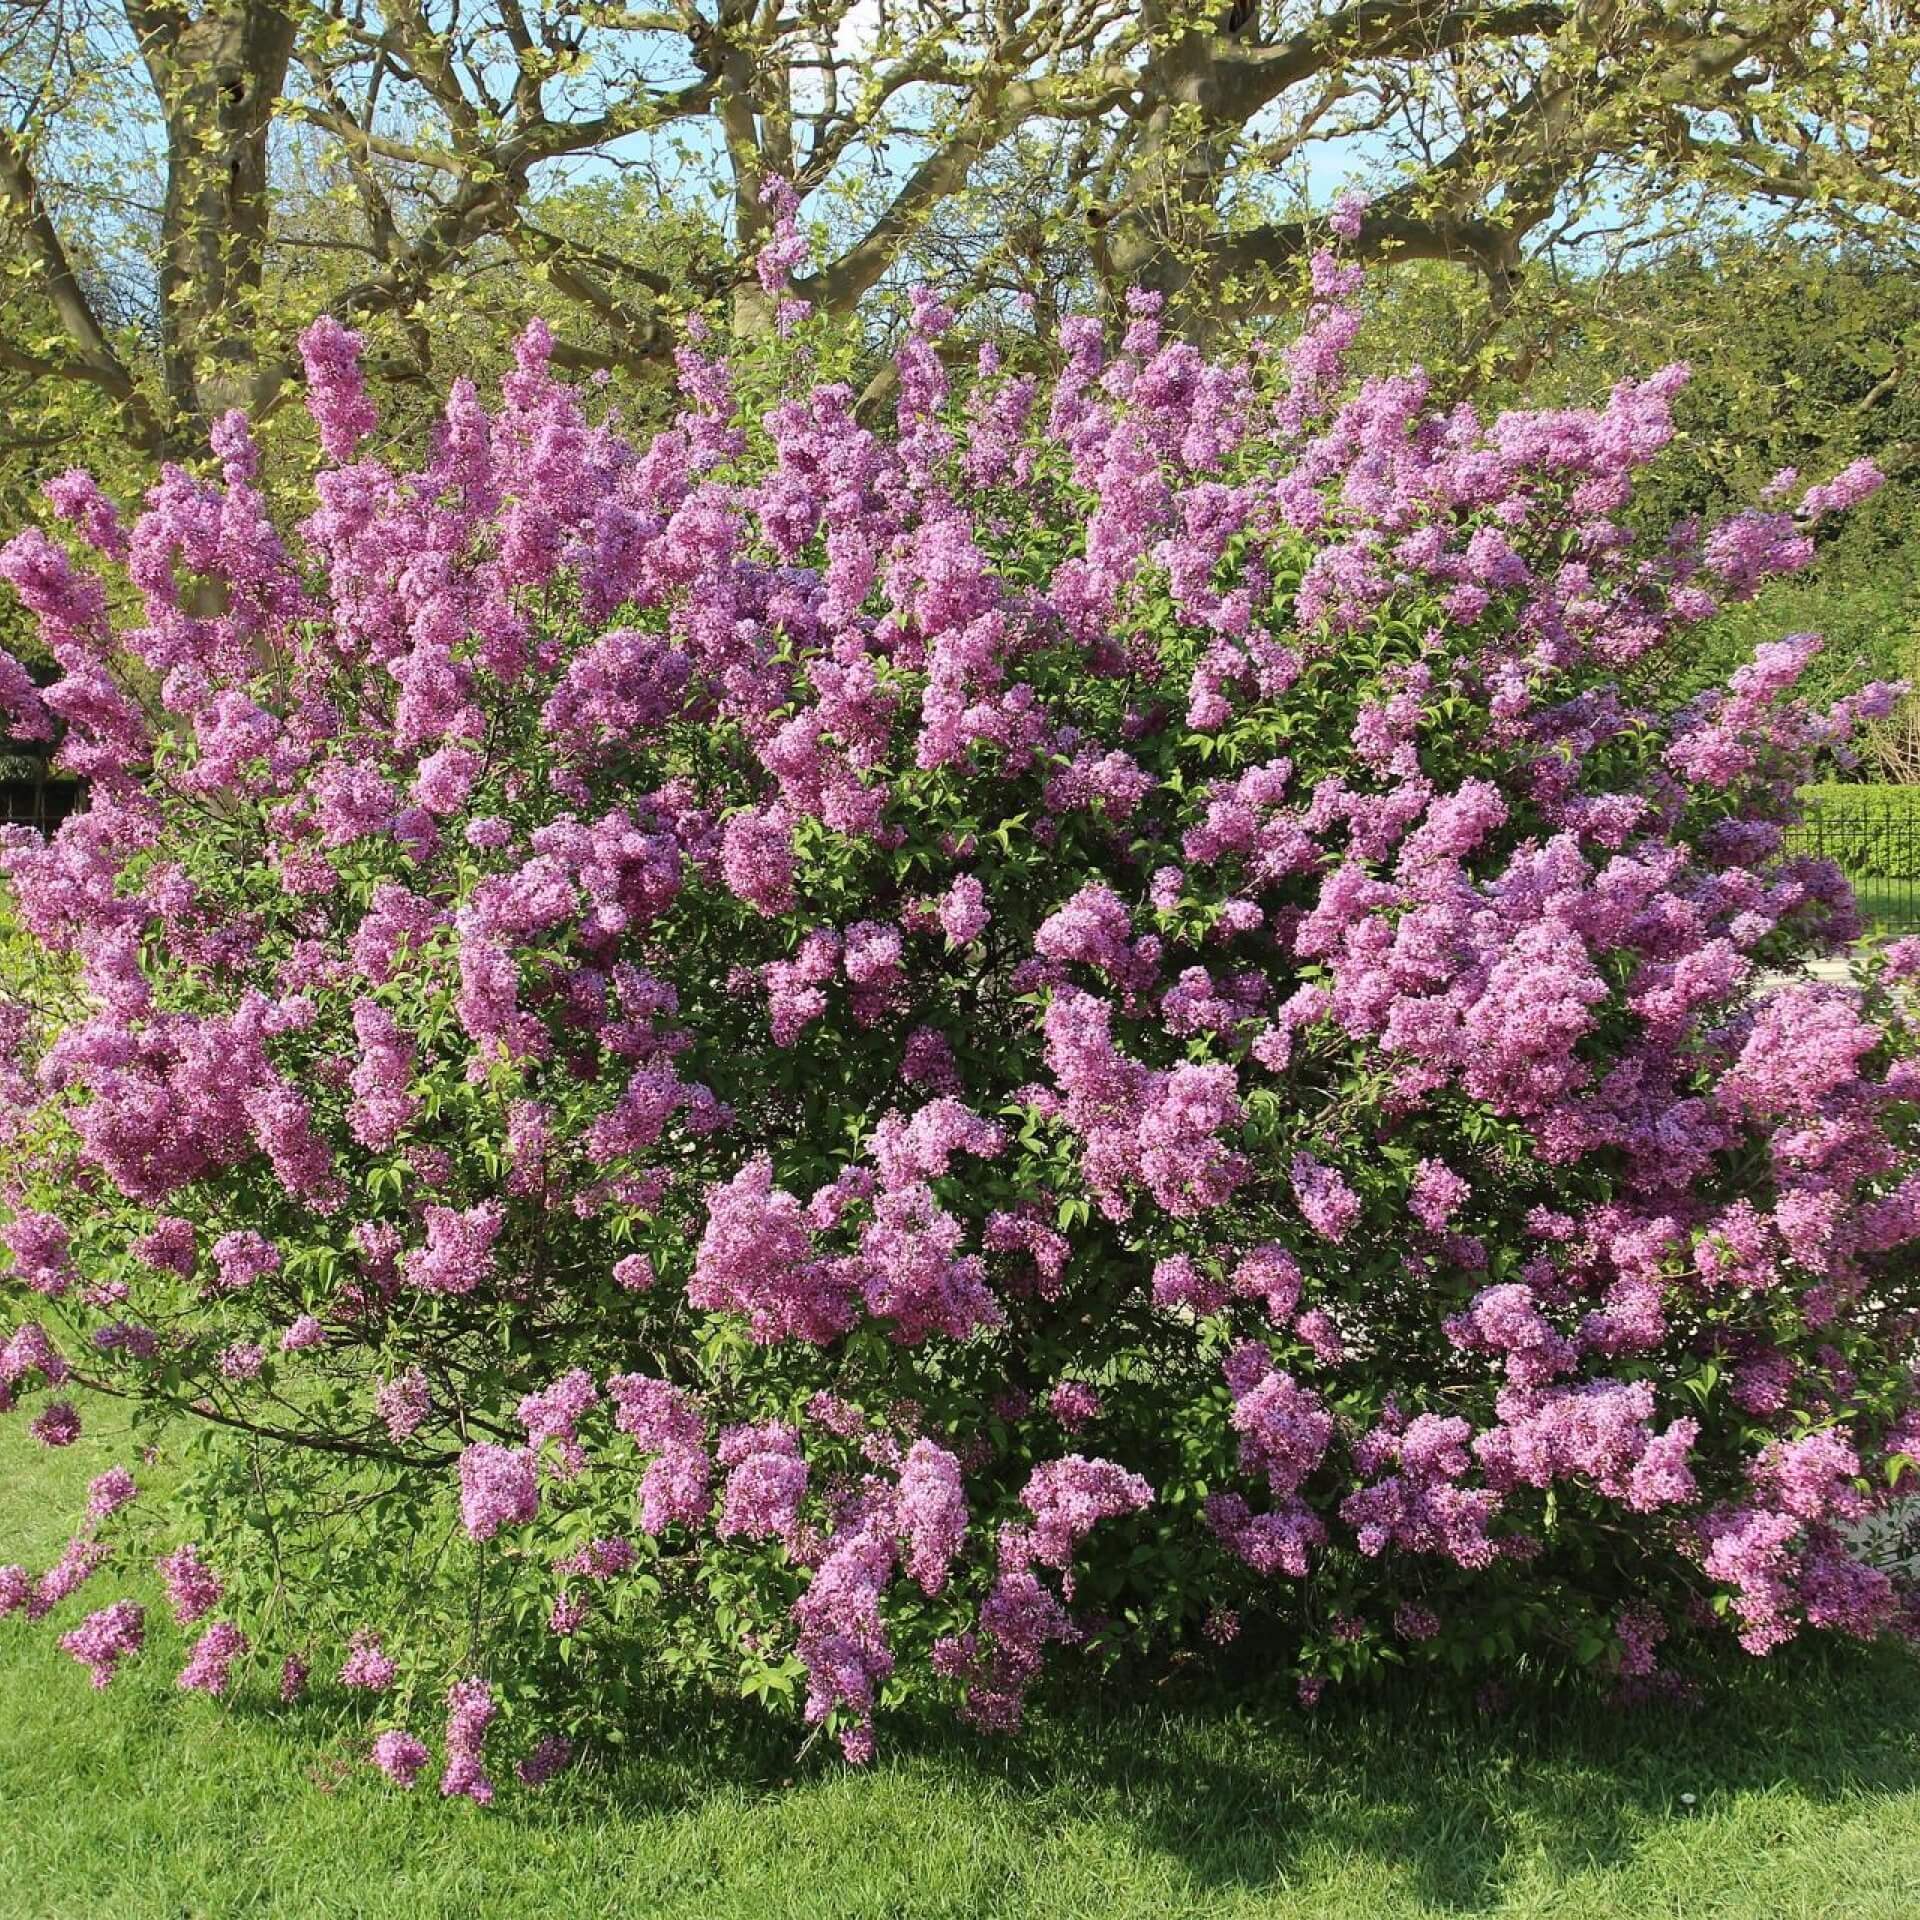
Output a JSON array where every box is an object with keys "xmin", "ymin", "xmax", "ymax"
[{"xmin": 0, "ymin": 243, "xmax": 1920, "ymax": 1803}]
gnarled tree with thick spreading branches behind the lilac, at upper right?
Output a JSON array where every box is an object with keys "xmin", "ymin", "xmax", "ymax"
[{"xmin": 1094, "ymin": 0, "xmax": 1920, "ymax": 334}]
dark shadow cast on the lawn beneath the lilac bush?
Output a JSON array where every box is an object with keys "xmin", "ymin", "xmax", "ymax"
[{"xmin": 449, "ymin": 1647, "xmax": 1920, "ymax": 1910}]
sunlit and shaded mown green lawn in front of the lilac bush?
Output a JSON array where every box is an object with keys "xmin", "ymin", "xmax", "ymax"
[{"xmin": 0, "ymin": 1421, "xmax": 1920, "ymax": 1920}]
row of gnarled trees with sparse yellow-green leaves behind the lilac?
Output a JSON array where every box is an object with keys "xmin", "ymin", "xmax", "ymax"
[{"xmin": 0, "ymin": 0, "xmax": 1920, "ymax": 478}]
